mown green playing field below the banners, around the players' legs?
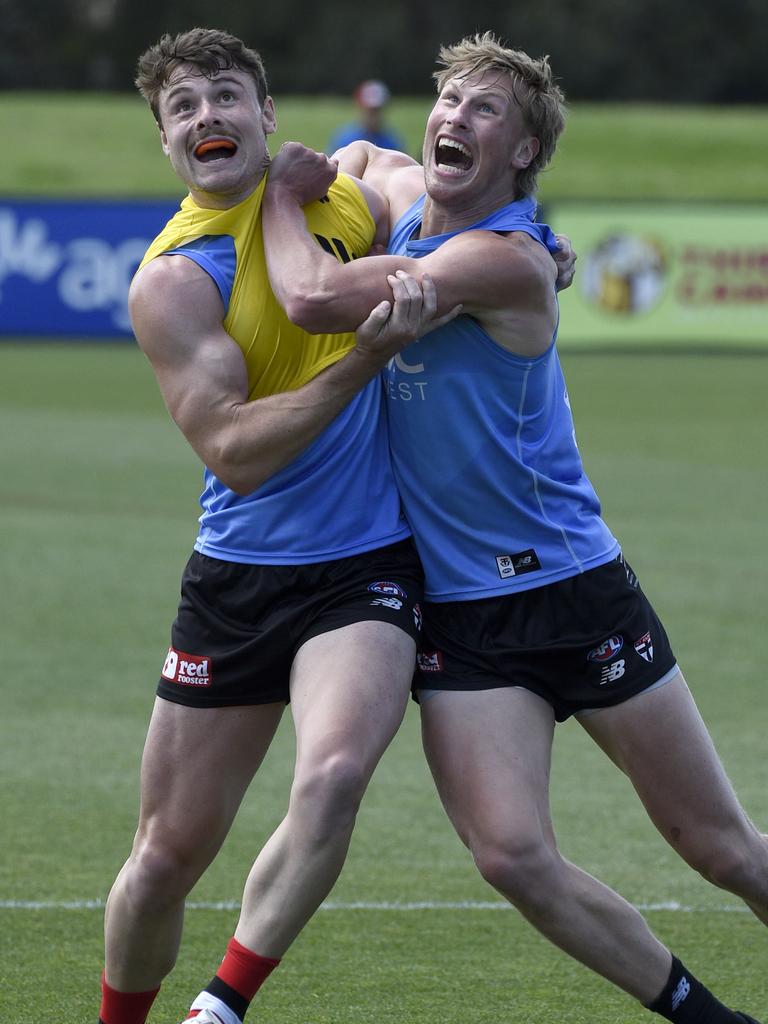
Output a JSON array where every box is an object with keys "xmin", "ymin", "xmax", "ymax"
[{"xmin": 0, "ymin": 346, "xmax": 768, "ymax": 1024}]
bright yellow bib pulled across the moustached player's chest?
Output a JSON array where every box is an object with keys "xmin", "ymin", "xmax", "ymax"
[{"xmin": 139, "ymin": 175, "xmax": 376, "ymax": 398}]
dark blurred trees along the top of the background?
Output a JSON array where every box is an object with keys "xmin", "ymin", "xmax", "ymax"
[{"xmin": 6, "ymin": 0, "xmax": 768, "ymax": 103}]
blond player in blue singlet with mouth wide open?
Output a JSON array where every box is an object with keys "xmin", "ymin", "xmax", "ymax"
[{"xmin": 264, "ymin": 33, "xmax": 768, "ymax": 1024}]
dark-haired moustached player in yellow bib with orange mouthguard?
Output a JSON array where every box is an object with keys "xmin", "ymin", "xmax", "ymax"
[{"xmin": 94, "ymin": 29, "xmax": 460, "ymax": 1024}]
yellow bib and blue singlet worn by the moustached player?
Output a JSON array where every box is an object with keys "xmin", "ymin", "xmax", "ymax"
[{"xmin": 141, "ymin": 175, "xmax": 410, "ymax": 564}]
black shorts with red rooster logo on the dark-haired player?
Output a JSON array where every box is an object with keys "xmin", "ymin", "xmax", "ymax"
[{"xmin": 158, "ymin": 540, "xmax": 422, "ymax": 708}]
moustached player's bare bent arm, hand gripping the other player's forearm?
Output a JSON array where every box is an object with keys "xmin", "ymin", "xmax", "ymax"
[{"xmin": 129, "ymin": 256, "xmax": 448, "ymax": 495}]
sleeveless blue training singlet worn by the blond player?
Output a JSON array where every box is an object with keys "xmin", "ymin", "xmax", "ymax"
[{"xmin": 385, "ymin": 197, "xmax": 620, "ymax": 601}]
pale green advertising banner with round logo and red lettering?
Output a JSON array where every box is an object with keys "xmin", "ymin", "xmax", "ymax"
[{"xmin": 543, "ymin": 201, "xmax": 768, "ymax": 347}]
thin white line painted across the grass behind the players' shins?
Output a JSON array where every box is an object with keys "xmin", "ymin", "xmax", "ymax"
[{"xmin": 0, "ymin": 899, "xmax": 748, "ymax": 913}]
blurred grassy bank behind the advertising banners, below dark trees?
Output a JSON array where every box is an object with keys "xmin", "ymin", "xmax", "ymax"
[{"xmin": 0, "ymin": 93, "xmax": 768, "ymax": 201}]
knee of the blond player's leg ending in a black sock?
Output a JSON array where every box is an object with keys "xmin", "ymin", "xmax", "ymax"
[{"xmin": 470, "ymin": 836, "xmax": 559, "ymax": 906}]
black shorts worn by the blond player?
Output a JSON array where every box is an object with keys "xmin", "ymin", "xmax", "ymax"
[{"xmin": 414, "ymin": 555, "xmax": 676, "ymax": 722}]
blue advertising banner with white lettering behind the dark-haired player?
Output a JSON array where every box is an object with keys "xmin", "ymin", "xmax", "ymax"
[{"xmin": 0, "ymin": 200, "xmax": 178, "ymax": 338}]
